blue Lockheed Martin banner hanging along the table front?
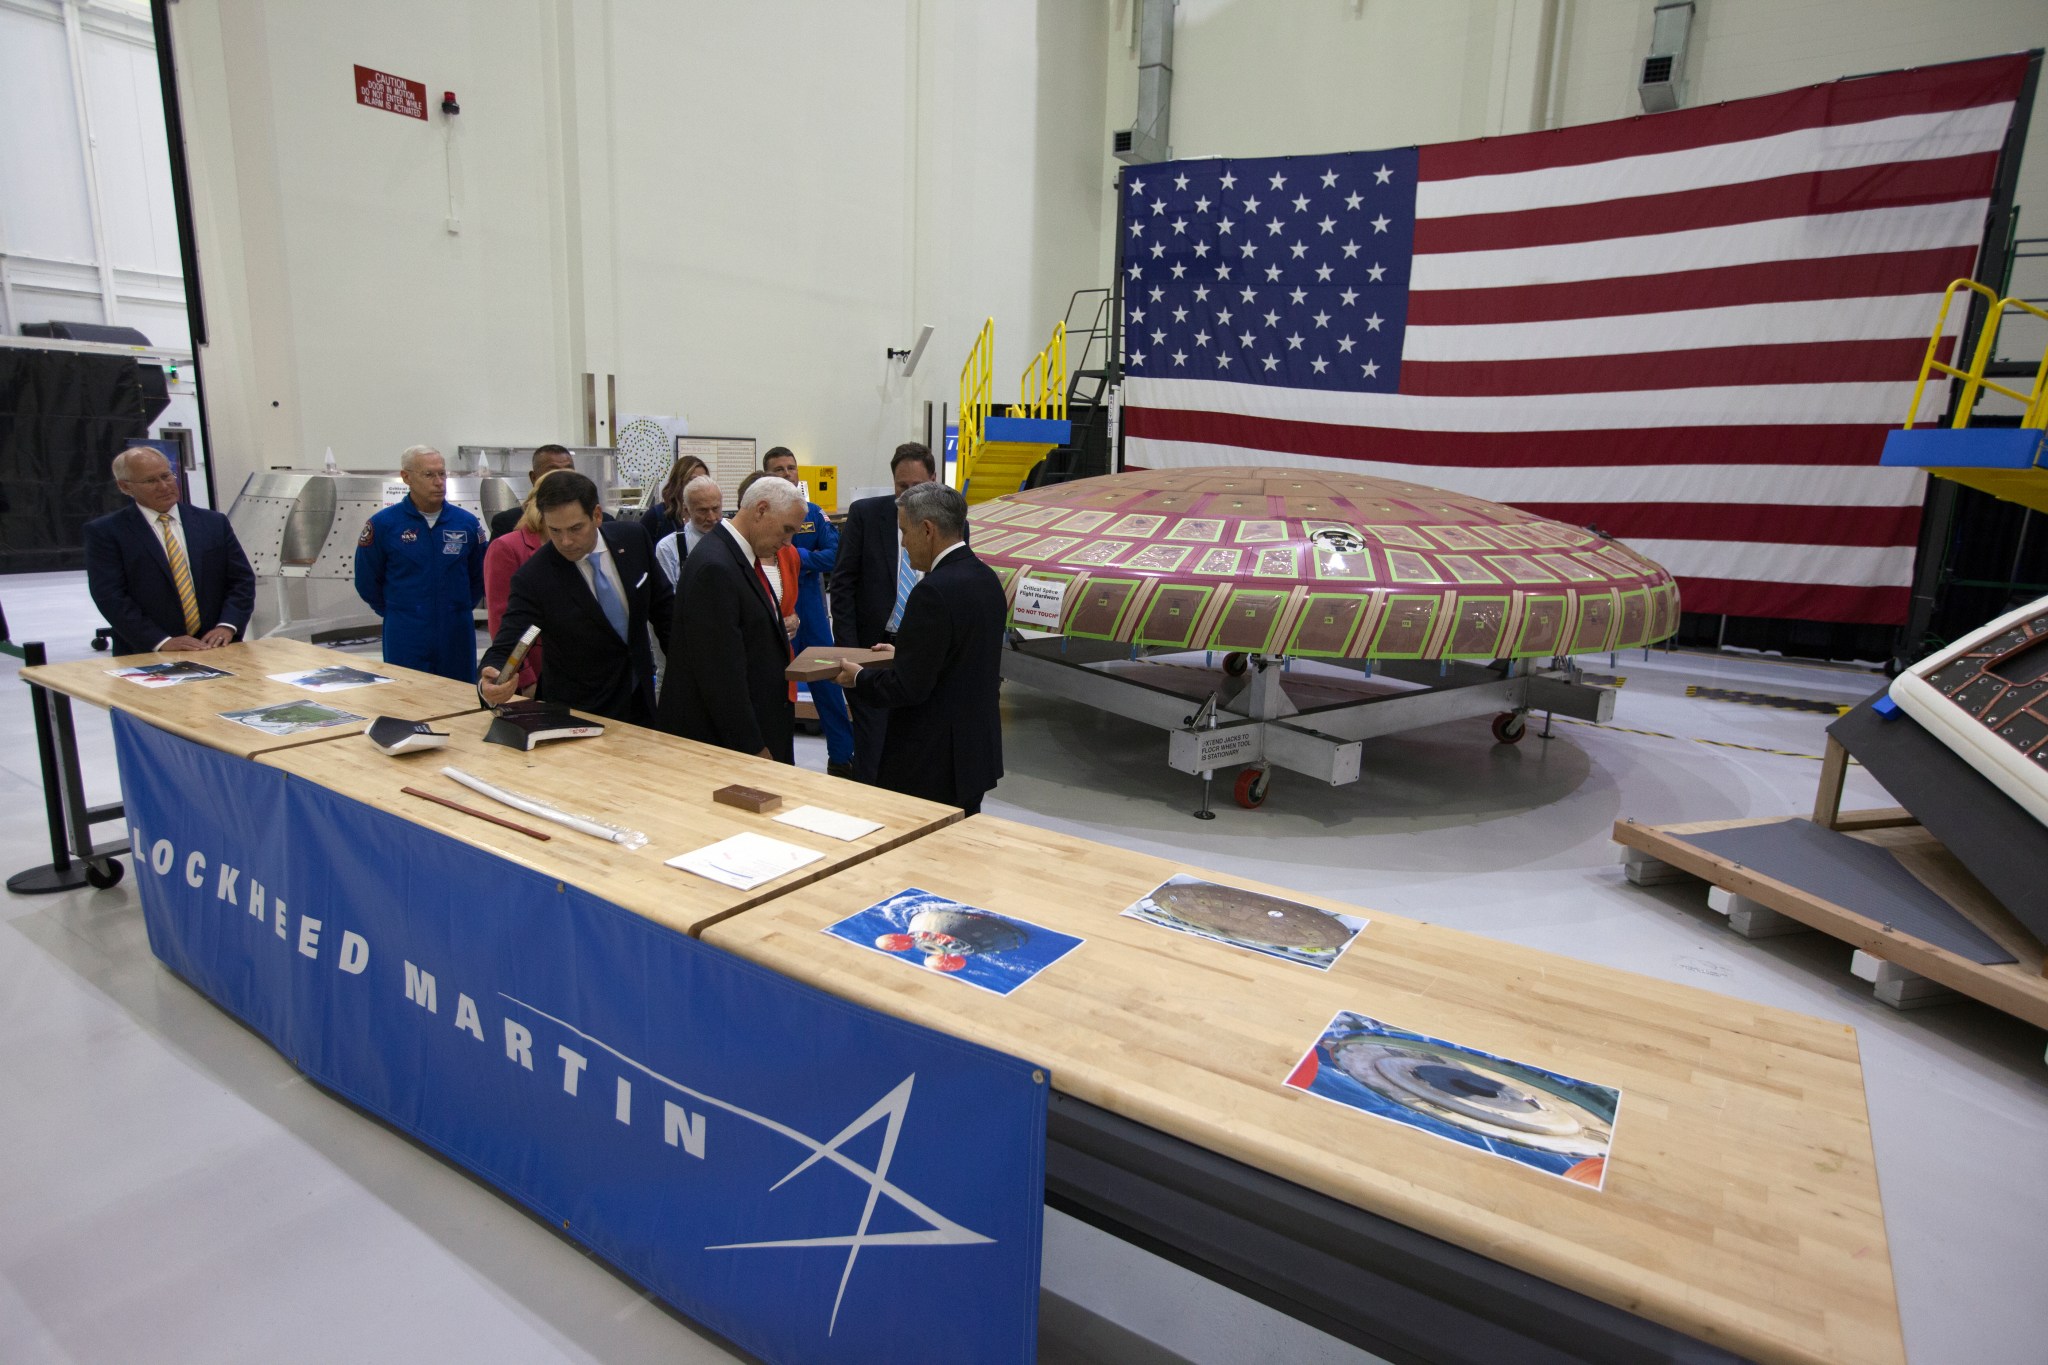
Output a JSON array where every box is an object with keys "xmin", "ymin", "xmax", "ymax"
[{"xmin": 115, "ymin": 712, "xmax": 1047, "ymax": 1365}]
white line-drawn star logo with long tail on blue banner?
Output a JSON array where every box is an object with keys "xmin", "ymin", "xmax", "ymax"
[{"xmin": 502, "ymin": 995, "xmax": 995, "ymax": 1336}]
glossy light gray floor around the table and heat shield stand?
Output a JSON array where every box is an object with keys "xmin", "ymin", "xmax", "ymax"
[{"xmin": 0, "ymin": 575, "xmax": 2048, "ymax": 1365}]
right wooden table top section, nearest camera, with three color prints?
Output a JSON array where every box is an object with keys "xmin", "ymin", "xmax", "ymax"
[{"xmin": 705, "ymin": 814, "xmax": 1905, "ymax": 1365}]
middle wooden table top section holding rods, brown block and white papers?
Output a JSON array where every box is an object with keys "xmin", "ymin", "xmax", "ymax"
[{"xmin": 258, "ymin": 712, "xmax": 961, "ymax": 933}]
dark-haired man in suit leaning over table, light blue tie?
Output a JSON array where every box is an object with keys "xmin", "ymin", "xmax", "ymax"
[{"xmin": 477, "ymin": 471, "xmax": 674, "ymax": 724}]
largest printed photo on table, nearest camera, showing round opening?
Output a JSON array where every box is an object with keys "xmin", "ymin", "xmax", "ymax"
[{"xmin": 1286, "ymin": 1011, "xmax": 1622, "ymax": 1189}]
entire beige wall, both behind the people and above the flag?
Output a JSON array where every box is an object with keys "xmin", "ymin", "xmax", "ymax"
[{"xmin": 172, "ymin": 0, "xmax": 2048, "ymax": 497}]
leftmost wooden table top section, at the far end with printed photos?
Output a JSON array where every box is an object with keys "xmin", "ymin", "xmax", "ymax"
[{"xmin": 20, "ymin": 639, "xmax": 481, "ymax": 757}]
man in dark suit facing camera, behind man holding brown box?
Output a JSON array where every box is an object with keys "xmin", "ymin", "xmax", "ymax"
[{"xmin": 831, "ymin": 440, "xmax": 938, "ymax": 782}]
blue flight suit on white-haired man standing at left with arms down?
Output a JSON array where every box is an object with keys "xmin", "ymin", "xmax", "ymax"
[{"xmin": 356, "ymin": 495, "xmax": 483, "ymax": 684}]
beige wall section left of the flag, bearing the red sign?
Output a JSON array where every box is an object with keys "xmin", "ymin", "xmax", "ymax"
[{"xmin": 172, "ymin": 0, "xmax": 1106, "ymax": 495}]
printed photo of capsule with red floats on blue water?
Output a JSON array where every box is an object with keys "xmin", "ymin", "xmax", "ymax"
[{"xmin": 821, "ymin": 886, "xmax": 1085, "ymax": 995}]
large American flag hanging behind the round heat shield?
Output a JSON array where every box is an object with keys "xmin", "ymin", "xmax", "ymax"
[{"xmin": 1120, "ymin": 55, "xmax": 2028, "ymax": 624}]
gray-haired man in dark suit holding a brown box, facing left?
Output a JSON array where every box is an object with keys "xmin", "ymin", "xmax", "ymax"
[{"xmin": 840, "ymin": 483, "xmax": 1010, "ymax": 814}]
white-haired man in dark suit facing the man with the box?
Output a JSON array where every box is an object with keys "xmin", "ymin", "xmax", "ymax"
[{"xmin": 659, "ymin": 477, "xmax": 805, "ymax": 763}]
